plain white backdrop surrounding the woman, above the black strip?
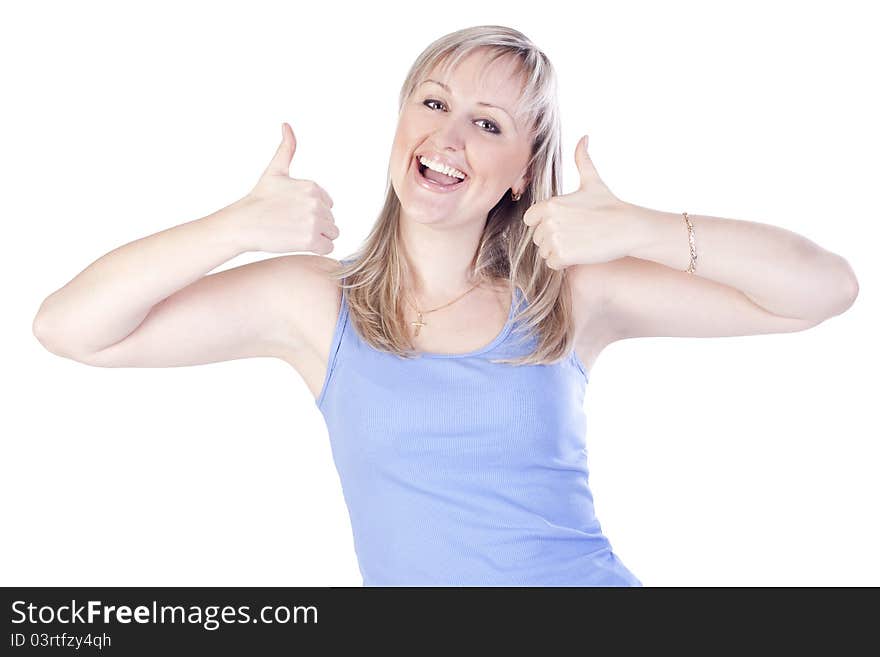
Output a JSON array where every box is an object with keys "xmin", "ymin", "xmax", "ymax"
[{"xmin": 0, "ymin": 0, "xmax": 880, "ymax": 586}]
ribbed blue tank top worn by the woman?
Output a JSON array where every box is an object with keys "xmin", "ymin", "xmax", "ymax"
[{"xmin": 315, "ymin": 270, "xmax": 642, "ymax": 586}]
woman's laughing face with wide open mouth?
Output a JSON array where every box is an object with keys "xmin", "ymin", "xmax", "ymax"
[{"xmin": 389, "ymin": 51, "xmax": 531, "ymax": 225}]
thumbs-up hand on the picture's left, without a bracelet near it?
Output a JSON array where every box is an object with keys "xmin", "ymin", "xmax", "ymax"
[{"xmin": 242, "ymin": 123, "xmax": 339, "ymax": 255}]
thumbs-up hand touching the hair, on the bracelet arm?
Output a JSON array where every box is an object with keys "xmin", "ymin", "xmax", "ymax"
[{"xmin": 523, "ymin": 135, "xmax": 647, "ymax": 270}]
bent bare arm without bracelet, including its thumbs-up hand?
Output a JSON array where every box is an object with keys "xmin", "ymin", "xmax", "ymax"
[{"xmin": 33, "ymin": 123, "xmax": 338, "ymax": 367}]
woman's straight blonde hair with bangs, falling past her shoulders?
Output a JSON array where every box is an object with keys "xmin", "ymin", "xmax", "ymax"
[{"xmin": 330, "ymin": 25, "xmax": 574, "ymax": 365}]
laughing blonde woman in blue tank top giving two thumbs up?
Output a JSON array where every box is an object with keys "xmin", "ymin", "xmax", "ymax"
[{"xmin": 34, "ymin": 26, "xmax": 858, "ymax": 586}]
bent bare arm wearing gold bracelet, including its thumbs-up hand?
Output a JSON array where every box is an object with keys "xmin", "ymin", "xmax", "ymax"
[{"xmin": 522, "ymin": 136, "xmax": 859, "ymax": 328}]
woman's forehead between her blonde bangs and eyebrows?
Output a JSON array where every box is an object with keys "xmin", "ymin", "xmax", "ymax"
[{"xmin": 420, "ymin": 50, "xmax": 524, "ymax": 110}]
